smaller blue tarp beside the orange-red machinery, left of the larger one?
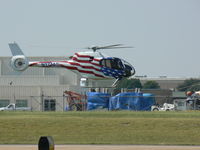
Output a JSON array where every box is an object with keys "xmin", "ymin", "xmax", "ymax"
[{"xmin": 87, "ymin": 92, "xmax": 111, "ymax": 110}]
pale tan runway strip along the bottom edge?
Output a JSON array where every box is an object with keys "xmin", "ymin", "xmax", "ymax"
[{"xmin": 0, "ymin": 145, "xmax": 200, "ymax": 150}]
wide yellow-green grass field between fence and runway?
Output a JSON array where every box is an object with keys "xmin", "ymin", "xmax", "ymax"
[{"xmin": 0, "ymin": 111, "xmax": 200, "ymax": 145}]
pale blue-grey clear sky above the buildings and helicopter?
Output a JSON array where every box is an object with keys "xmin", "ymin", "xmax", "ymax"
[{"xmin": 0, "ymin": 0, "xmax": 200, "ymax": 78}]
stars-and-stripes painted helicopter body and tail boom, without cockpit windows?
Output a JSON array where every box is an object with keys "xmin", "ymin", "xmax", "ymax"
[{"xmin": 29, "ymin": 52, "xmax": 115, "ymax": 79}]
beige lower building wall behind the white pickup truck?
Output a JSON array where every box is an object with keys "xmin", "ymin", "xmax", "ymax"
[{"xmin": 0, "ymin": 86, "xmax": 80, "ymax": 111}]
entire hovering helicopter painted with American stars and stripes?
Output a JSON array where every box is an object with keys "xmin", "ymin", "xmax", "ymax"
[{"xmin": 9, "ymin": 42, "xmax": 135, "ymax": 86}]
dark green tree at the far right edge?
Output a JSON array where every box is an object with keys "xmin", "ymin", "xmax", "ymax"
[{"xmin": 177, "ymin": 78, "xmax": 200, "ymax": 91}]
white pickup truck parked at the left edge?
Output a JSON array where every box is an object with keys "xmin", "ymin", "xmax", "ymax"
[{"xmin": 0, "ymin": 103, "xmax": 31, "ymax": 111}]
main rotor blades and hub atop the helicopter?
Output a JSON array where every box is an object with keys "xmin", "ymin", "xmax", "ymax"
[{"xmin": 86, "ymin": 44, "xmax": 134, "ymax": 52}]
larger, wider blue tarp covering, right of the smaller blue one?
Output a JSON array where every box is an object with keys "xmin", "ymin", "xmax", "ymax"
[{"xmin": 109, "ymin": 92, "xmax": 155, "ymax": 111}]
